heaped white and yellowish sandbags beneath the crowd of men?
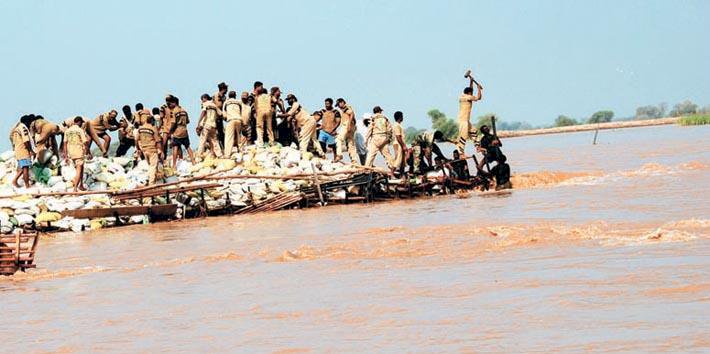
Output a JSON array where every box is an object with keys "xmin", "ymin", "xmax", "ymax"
[{"xmin": 0, "ymin": 146, "xmax": 352, "ymax": 233}]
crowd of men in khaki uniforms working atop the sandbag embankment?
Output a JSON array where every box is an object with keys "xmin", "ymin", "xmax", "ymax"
[{"xmin": 10, "ymin": 75, "xmax": 509, "ymax": 190}]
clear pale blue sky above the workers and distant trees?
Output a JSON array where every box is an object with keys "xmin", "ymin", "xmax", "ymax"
[{"xmin": 0, "ymin": 0, "xmax": 710, "ymax": 146}]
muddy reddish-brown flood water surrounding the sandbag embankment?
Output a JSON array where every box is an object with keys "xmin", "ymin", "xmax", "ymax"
[{"xmin": 0, "ymin": 126, "xmax": 710, "ymax": 353}]
